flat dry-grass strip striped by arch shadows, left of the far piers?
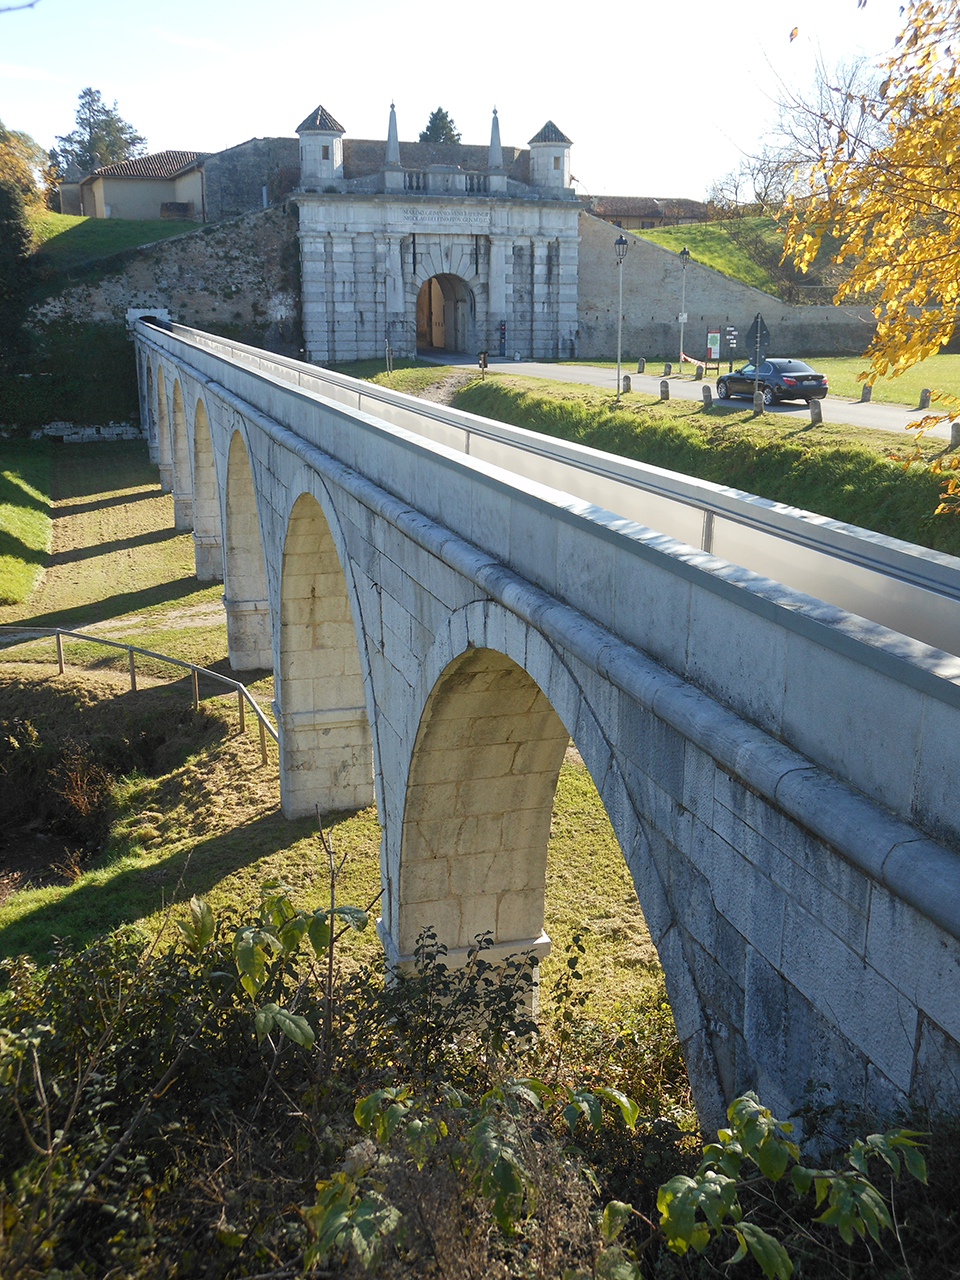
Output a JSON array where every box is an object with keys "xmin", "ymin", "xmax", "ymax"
[{"xmin": 0, "ymin": 442, "xmax": 198, "ymax": 627}]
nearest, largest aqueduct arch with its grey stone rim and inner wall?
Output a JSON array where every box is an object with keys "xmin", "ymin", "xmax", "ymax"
[{"xmin": 378, "ymin": 602, "xmax": 732, "ymax": 1128}]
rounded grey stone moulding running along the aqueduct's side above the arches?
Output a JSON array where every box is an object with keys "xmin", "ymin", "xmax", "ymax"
[{"xmin": 138, "ymin": 335, "xmax": 960, "ymax": 938}]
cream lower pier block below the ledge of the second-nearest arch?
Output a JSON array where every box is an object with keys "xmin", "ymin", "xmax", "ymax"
[{"xmin": 274, "ymin": 704, "xmax": 375, "ymax": 818}]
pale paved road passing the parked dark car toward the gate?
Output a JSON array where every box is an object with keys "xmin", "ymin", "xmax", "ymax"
[{"xmin": 419, "ymin": 352, "xmax": 950, "ymax": 440}]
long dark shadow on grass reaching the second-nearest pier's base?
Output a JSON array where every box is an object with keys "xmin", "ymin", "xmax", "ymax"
[{"xmin": 0, "ymin": 810, "xmax": 323, "ymax": 961}]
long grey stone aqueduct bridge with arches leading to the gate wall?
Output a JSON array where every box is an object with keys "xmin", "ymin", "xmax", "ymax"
[{"xmin": 137, "ymin": 321, "xmax": 960, "ymax": 1120}]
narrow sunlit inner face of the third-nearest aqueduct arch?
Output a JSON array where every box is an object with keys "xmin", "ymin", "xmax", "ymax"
[{"xmin": 223, "ymin": 430, "xmax": 273, "ymax": 671}]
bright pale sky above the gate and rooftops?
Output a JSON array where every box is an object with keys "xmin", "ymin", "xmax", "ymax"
[{"xmin": 0, "ymin": 0, "xmax": 901, "ymax": 198}]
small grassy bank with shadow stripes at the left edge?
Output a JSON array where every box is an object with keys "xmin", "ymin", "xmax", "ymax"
[{"xmin": 0, "ymin": 440, "xmax": 52, "ymax": 605}]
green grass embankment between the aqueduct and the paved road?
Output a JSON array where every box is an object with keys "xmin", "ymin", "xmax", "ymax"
[{"xmin": 454, "ymin": 375, "xmax": 960, "ymax": 554}]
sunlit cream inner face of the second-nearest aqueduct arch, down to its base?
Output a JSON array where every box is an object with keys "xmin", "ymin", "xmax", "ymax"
[{"xmin": 278, "ymin": 490, "xmax": 374, "ymax": 817}]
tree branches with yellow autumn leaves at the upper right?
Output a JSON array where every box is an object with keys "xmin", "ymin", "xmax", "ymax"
[{"xmin": 786, "ymin": 0, "xmax": 960, "ymax": 511}]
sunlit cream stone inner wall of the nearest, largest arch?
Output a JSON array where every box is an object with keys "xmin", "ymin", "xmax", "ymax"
[{"xmin": 394, "ymin": 648, "xmax": 570, "ymax": 955}]
